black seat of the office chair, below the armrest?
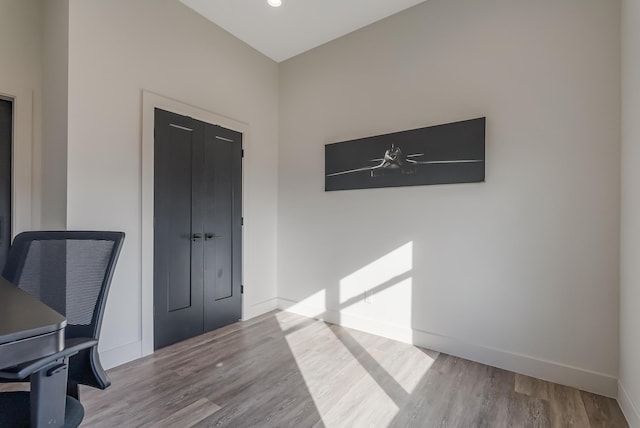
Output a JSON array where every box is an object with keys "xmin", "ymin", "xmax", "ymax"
[{"xmin": 0, "ymin": 391, "xmax": 84, "ymax": 428}]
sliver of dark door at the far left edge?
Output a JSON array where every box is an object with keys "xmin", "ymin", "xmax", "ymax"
[{"xmin": 0, "ymin": 99, "xmax": 13, "ymax": 271}]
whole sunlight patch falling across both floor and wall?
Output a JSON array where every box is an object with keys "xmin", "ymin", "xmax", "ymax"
[{"xmin": 276, "ymin": 242, "xmax": 428, "ymax": 427}]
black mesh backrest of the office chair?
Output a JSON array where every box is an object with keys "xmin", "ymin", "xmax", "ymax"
[{"xmin": 2, "ymin": 231, "xmax": 124, "ymax": 339}]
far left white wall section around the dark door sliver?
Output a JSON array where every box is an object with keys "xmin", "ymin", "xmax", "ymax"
[{"xmin": 0, "ymin": 0, "xmax": 42, "ymax": 234}]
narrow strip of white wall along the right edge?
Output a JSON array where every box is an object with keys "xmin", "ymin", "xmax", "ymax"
[{"xmin": 618, "ymin": 0, "xmax": 640, "ymax": 427}]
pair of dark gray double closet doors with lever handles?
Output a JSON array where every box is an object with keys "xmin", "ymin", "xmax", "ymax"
[{"xmin": 154, "ymin": 109, "xmax": 242, "ymax": 349}]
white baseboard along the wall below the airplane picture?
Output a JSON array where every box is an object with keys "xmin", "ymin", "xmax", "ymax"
[{"xmin": 278, "ymin": 298, "xmax": 616, "ymax": 398}]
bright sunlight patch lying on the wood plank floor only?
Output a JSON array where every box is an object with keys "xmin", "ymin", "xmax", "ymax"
[{"xmin": 276, "ymin": 312, "xmax": 437, "ymax": 427}]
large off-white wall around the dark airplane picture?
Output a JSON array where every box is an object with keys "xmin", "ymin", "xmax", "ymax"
[{"xmin": 278, "ymin": 0, "xmax": 620, "ymax": 396}]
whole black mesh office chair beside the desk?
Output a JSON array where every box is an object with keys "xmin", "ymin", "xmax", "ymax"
[{"xmin": 0, "ymin": 231, "xmax": 124, "ymax": 428}]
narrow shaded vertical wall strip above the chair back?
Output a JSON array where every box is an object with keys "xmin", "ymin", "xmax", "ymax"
[{"xmin": 40, "ymin": 0, "xmax": 69, "ymax": 230}]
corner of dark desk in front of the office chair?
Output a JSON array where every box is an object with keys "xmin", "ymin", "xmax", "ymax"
[{"xmin": 0, "ymin": 276, "xmax": 67, "ymax": 369}]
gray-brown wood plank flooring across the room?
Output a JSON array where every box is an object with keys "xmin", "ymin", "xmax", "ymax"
[{"xmin": 1, "ymin": 311, "xmax": 627, "ymax": 428}]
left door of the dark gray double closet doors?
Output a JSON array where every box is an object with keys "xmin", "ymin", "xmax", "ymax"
[{"xmin": 154, "ymin": 109, "xmax": 204, "ymax": 349}]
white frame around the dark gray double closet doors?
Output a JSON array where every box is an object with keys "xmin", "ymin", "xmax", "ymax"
[{"xmin": 140, "ymin": 90, "xmax": 250, "ymax": 356}]
